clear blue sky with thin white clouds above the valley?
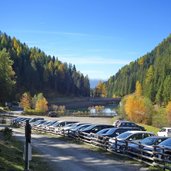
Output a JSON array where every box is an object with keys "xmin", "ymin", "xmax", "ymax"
[{"xmin": 0, "ymin": 0, "xmax": 171, "ymax": 80}]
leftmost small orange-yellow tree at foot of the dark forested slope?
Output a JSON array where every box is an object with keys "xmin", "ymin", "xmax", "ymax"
[{"xmin": 20, "ymin": 92, "xmax": 31, "ymax": 111}]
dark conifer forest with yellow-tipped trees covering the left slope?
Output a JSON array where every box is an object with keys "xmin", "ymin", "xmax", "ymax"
[{"xmin": 0, "ymin": 32, "xmax": 90, "ymax": 102}]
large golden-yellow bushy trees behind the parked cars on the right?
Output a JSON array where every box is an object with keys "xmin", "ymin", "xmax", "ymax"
[{"xmin": 118, "ymin": 81, "xmax": 171, "ymax": 128}]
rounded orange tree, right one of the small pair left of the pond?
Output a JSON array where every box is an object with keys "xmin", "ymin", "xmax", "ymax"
[{"xmin": 35, "ymin": 97, "xmax": 48, "ymax": 112}]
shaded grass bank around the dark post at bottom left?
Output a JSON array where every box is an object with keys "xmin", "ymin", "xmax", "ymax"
[{"xmin": 0, "ymin": 136, "xmax": 50, "ymax": 171}]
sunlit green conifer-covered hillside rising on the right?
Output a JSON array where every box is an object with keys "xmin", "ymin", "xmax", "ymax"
[{"xmin": 106, "ymin": 35, "xmax": 171, "ymax": 104}]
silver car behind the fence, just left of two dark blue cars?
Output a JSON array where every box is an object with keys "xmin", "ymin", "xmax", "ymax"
[{"xmin": 108, "ymin": 131, "xmax": 154, "ymax": 152}]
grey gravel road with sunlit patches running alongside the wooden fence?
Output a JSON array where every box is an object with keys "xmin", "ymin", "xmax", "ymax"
[{"xmin": 14, "ymin": 129, "xmax": 146, "ymax": 171}]
